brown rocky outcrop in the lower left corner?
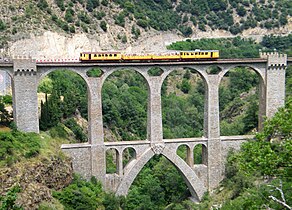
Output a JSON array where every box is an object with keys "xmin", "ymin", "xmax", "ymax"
[{"xmin": 0, "ymin": 156, "xmax": 73, "ymax": 210}]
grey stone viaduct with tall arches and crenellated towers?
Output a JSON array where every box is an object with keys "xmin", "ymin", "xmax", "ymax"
[{"xmin": 0, "ymin": 53, "xmax": 287, "ymax": 200}]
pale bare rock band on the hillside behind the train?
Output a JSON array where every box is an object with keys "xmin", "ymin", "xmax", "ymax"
[{"xmin": 8, "ymin": 19, "xmax": 292, "ymax": 59}]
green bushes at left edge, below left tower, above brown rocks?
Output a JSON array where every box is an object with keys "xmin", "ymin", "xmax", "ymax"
[{"xmin": 0, "ymin": 131, "xmax": 41, "ymax": 166}]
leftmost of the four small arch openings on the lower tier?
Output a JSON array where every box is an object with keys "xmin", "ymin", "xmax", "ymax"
[{"xmin": 105, "ymin": 148, "xmax": 120, "ymax": 174}]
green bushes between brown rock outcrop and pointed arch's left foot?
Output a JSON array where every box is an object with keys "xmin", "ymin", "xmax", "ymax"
[{"xmin": 53, "ymin": 175, "xmax": 123, "ymax": 210}]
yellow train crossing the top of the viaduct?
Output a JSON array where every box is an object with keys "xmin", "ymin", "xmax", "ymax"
[{"xmin": 79, "ymin": 50, "xmax": 219, "ymax": 62}]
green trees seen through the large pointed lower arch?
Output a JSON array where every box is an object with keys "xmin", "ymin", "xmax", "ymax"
[{"xmin": 125, "ymin": 156, "xmax": 190, "ymax": 209}]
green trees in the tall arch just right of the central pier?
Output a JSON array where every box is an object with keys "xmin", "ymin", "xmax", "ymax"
[{"xmin": 162, "ymin": 73, "xmax": 205, "ymax": 138}]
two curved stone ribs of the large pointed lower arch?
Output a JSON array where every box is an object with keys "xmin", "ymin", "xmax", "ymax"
[{"xmin": 116, "ymin": 145, "xmax": 207, "ymax": 201}]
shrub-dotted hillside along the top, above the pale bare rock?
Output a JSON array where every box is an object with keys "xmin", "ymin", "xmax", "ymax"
[{"xmin": 0, "ymin": 0, "xmax": 292, "ymax": 47}]
